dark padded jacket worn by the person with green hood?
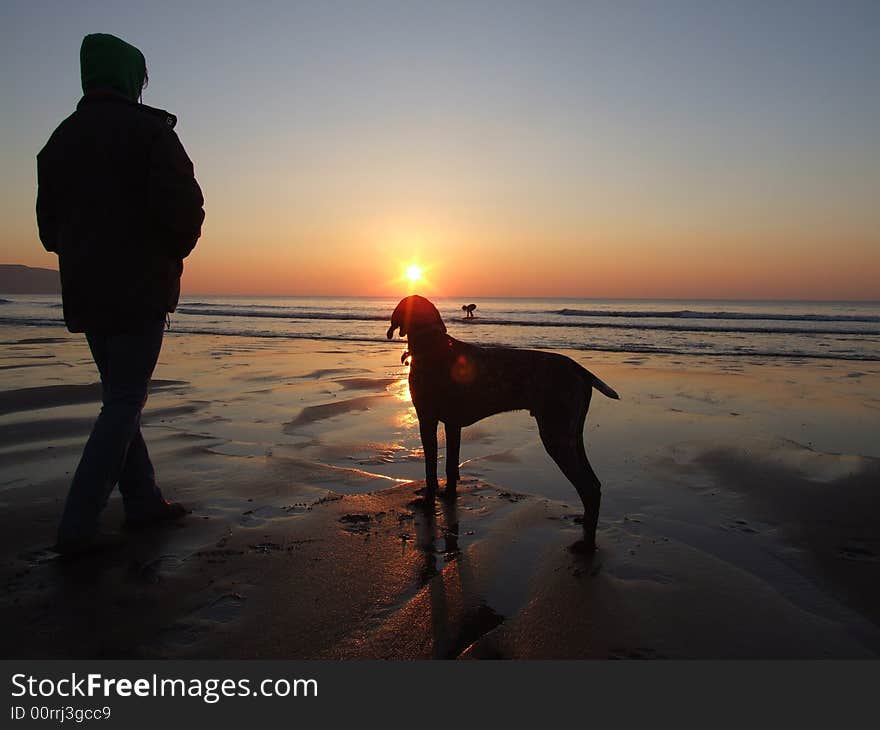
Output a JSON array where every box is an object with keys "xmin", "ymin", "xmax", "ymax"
[{"xmin": 37, "ymin": 36, "xmax": 205, "ymax": 332}]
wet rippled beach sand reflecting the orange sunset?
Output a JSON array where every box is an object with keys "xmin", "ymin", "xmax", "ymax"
[{"xmin": 0, "ymin": 327, "xmax": 880, "ymax": 659}]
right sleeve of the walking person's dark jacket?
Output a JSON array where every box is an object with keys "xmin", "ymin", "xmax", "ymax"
[{"xmin": 148, "ymin": 129, "xmax": 205, "ymax": 259}]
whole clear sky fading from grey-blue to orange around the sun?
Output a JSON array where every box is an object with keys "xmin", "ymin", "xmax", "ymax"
[{"xmin": 0, "ymin": 3, "xmax": 880, "ymax": 299}]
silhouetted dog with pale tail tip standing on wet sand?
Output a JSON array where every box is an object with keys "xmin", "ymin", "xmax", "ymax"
[{"xmin": 387, "ymin": 295, "xmax": 619, "ymax": 549}]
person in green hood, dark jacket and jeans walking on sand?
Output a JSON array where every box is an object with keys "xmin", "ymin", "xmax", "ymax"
[{"xmin": 37, "ymin": 33, "xmax": 205, "ymax": 555}]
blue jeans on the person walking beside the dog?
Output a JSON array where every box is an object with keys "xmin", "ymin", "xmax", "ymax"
[{"xmin": 58, "ymin": 322, "xmax": 170, "ymax": 541}]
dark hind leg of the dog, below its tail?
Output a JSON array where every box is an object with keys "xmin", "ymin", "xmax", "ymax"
[{"xmin": 535, "ymin": 401, "xmax": 602, "ymax": 549}]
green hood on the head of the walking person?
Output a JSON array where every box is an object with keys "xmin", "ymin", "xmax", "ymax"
[{"xmin": 79, "ymin": 33, "xmax": 147, "ymax": 101}]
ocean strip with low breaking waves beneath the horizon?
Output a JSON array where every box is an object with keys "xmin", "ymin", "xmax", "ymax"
[{"xmin": 0, "ymin": 295, "xmax": 880, "ymax": 362}]
